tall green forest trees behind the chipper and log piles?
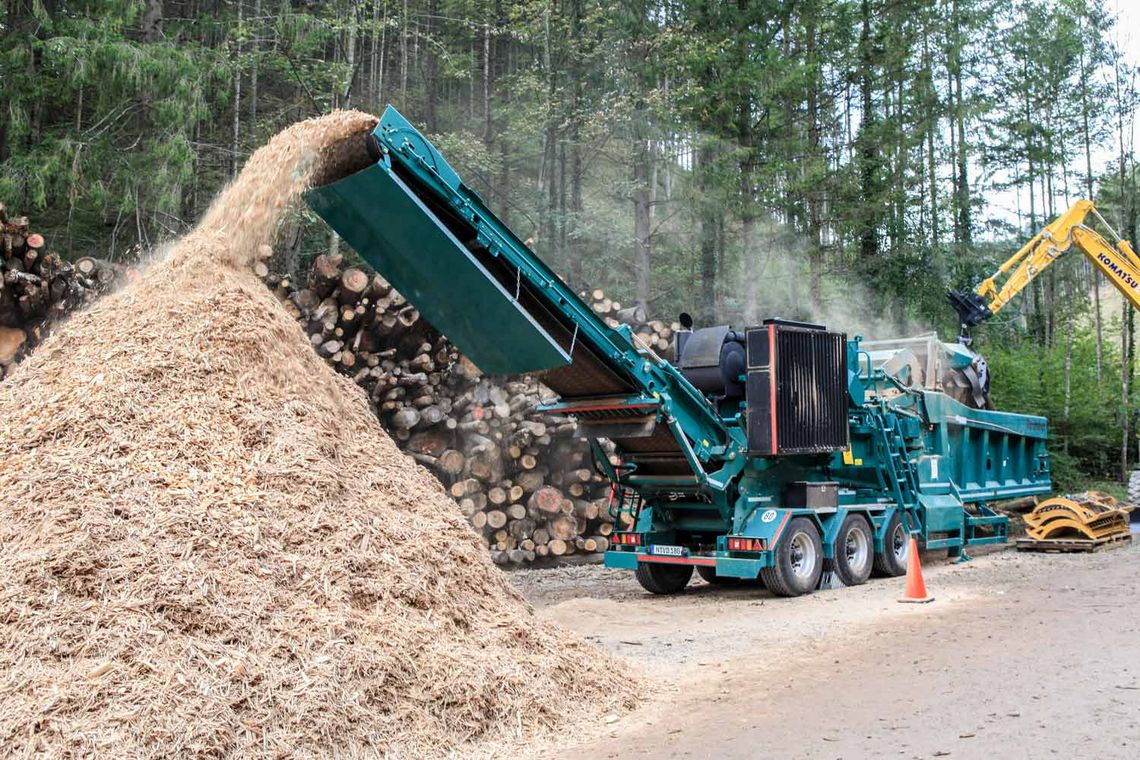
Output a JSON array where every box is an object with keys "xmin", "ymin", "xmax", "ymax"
[{"xmin": 0, "ymin": 0, "xmax": 1138, "ymax": 488}]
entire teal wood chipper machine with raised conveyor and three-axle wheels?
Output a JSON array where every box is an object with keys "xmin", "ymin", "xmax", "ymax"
[{"xmin": 307, "ymin": 107, "xmax": 1051, "ymax": 596}]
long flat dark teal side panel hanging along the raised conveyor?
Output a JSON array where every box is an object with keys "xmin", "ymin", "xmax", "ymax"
[{"xmin": 307, "ymin": 164, "xmax": 570, "ymax": 375}]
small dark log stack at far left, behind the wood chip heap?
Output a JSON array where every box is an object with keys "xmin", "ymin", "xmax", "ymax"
[{"xmin": 0, "ymin": 203, "xmax": 123, "ymax": 377}]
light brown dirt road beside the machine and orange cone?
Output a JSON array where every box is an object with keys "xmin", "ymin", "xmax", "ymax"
[{"xmin": 513, "ymin": 546, "xmax": 1140, "ymax": 760}]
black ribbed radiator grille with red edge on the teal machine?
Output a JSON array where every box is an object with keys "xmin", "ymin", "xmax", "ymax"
[{"xmin": 747, "ymin": 322, "xmax": 848, "ymax": 455}]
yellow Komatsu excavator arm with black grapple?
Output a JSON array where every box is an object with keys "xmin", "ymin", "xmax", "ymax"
[{"xmin": 948, "ymin": 201, "xmax": 1140, "ymax": 333}]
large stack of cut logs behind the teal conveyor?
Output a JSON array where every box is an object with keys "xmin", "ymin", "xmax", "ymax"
[{"xmin": 263, "ymin": 254, "xmax": 674, "ymax": 564}]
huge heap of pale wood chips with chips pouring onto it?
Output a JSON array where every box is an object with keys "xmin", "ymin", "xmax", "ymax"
[{"xmin": 0, "ymin": 113, "xmax": 638, "ymax": 758}]
